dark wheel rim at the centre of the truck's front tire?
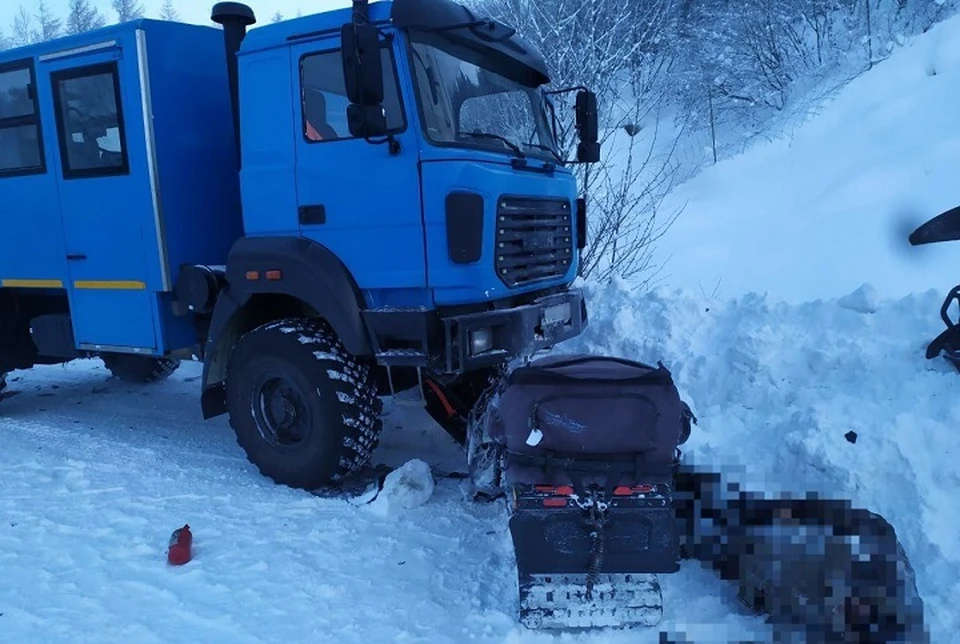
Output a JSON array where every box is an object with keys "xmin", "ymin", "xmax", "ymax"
[{"xmin": 251, "ymin": 374, "xmax": 311, "ymax": 449}]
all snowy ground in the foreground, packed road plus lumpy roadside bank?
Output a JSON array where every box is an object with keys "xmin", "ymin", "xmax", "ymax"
[{"xmin": 0, "ymin": 286, "xmax": 960, "ymax": 643}]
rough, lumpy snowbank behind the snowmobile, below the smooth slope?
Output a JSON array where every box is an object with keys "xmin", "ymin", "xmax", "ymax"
[{"xmin": 563, "ymin": 285, "xmax": 960, "ymax": 643}]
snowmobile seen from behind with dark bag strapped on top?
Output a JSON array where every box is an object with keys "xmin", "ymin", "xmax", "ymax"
[{"xmin": 470, "ymin": 354, "xmax": 693, "ymax": 628}]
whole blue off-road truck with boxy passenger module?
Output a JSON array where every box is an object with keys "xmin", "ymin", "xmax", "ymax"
[{"xmin": 0, "ymin": 0, "xmax": 599, "ymax": 489}]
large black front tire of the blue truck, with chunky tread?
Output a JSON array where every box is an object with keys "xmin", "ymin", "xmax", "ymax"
[{"xmin": 226, "ymin": 318, "xmax": 383, "ymax": 490}]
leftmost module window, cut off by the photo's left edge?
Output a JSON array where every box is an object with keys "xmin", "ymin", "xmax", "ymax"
[{"xmin": 0, "ymin": 60, "xmax": 46, "ymax": 177}]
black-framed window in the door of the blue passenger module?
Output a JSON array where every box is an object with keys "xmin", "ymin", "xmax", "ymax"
[{"xmin": 53, "ymin": 63, "xmax": 130, "ymax": 179}]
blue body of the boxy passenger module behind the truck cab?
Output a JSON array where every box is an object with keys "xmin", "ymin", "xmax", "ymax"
[{"xmin": 0, "ymin": 20, "xmax": 242, "ymax": 354}]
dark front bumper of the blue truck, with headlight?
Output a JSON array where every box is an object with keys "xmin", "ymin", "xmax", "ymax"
[{"xmin": 442, "ymin": 289, "xmax": 587, "ymax": 374}]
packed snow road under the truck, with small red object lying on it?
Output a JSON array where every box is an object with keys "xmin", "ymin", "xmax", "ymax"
[{"xmin": 0, "ymin": 352, "xmax": 767, "ymax": 643}]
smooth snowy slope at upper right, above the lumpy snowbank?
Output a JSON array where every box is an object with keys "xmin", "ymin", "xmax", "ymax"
[{"xmin": 656, "ymin": 10, "xmax": 960, "ymax": 301}]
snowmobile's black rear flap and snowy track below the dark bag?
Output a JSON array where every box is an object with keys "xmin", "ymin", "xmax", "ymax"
[{"xmin": 509, "ymin": 486, "xmax": 679, "ymax": 629}]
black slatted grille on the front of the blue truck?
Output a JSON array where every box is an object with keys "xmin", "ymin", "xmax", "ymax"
[{"xmin": 495, "ymin": 197, "xmax": 573, "ymax": 286}]
